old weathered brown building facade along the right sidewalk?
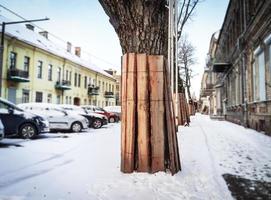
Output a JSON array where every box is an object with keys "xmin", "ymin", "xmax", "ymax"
[{"xmin": 213, "ymin": 0, "xmax": 271, "ymax": 134}]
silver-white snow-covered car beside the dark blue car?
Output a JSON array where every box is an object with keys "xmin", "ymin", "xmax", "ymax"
[{"xmin": 18, "ymin": 103, "xmax": 88, "ymax": 132}]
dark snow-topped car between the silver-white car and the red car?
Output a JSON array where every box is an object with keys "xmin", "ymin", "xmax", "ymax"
[{"xmin": 59, "ymin": 104, "xmax": 108, "ymax": 129}]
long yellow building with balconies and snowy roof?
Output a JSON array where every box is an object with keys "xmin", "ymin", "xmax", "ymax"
[{"xmin": 1, "ymin": 20, "xmax": 116, "ymax": 107}]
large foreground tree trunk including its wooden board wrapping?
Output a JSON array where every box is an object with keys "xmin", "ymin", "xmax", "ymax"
[{"xmin": 99, "ymin": 0, "xmax": 181, "ymax": 174}]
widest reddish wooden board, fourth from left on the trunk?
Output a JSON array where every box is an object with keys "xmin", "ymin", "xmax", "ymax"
[{"xmin": 148, "ymin": 56, "xmax": 165, "ymax": 173}]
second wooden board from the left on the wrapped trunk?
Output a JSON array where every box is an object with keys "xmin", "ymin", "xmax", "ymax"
[{"xmin": 125, "ymin": 53, "xmax": 137, "ymax": 173}]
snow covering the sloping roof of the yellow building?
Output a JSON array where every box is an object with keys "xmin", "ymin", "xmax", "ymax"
[{"xmin": 0, "ymin": 15, "xmax": 113, "ymax": 78}]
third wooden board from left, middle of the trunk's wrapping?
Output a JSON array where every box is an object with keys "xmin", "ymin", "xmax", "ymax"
[{"xmin": 137, "ymin": 54, "xmax": 151, "ymax": 172}]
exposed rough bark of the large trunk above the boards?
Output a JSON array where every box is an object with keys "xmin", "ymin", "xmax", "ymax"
[{"xmin": 99, "ymin": 0, "xmax": 168, "ymax": 58}]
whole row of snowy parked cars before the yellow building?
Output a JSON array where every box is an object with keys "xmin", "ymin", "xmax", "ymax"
[{"xmin": 0, "ymin": 98, "xmax": 120, "ymax": 139}]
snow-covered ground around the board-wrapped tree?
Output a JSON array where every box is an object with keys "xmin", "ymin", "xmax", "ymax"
[{"xmin": 0, "ymin": 115, "xmax": 271, "ymax": 200}]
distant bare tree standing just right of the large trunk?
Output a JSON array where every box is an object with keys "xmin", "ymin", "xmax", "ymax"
[{"xmin": 178, "ymin": 37, "xmax": 196, "ymax": 99}]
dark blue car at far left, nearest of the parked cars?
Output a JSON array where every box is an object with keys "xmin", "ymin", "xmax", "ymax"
[{"xmin": 0, "ymin": 98, "xmax": 49, "ymax": 139}]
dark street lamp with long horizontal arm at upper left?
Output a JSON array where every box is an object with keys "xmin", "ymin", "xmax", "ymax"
[{"xmin": 0, "ymin": 17, "xmax": 49, "ymax": 97}]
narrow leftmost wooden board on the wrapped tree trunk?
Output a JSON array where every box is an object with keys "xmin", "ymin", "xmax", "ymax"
[{"xmin": 121, "ymin": 54, "xmax": 128, "ymax": 172}]
